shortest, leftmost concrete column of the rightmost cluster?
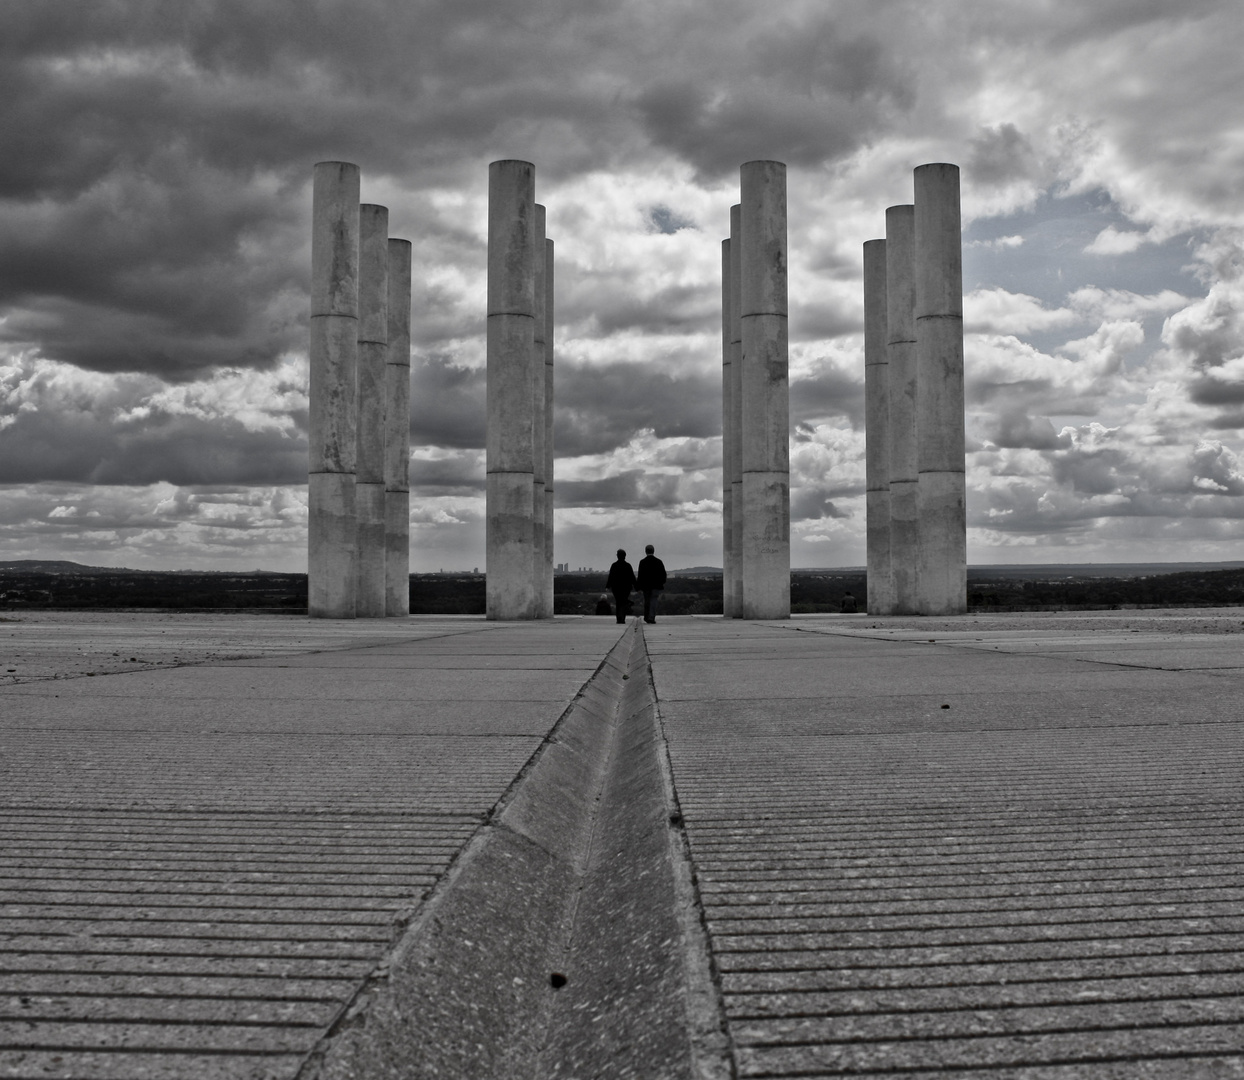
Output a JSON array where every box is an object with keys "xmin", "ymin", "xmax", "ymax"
[{"xmin": 863, "ymin": 240, "xmax": 894, "ymax": 615}]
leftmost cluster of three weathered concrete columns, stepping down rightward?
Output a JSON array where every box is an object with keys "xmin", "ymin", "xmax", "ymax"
[{"xmin": 307, "ymin": 162, "xmax": 411, "ymax": 618}]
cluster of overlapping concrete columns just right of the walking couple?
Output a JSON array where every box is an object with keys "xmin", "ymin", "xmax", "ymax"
[{"xmin": 722, "ymin": 162, "xmax": 790, "ymax": 618}]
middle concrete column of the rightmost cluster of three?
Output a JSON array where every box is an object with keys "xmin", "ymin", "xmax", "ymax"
[{"xmin": 886, "ymin": 204, "xmax": 921, "ymax": 615}]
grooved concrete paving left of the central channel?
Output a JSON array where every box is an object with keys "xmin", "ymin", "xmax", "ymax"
[{"xmin": 0, "ymin": 613, "xmax": 621, "ymax": 1078}]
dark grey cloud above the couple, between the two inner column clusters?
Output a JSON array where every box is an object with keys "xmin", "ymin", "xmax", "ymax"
[{"xmin": 555, "ymin": 361, "xmax": 722, "ymax": 450}]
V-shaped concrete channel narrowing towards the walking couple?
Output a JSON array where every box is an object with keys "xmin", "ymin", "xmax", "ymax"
[{"xmin": 299, "ymin": 621, "xmax": 735, "ymax": 1080}]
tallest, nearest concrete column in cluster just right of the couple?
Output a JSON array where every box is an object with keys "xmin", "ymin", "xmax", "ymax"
[{"xmin": 739, "ymin": 162, "xmax": 790, "ymax": 618}]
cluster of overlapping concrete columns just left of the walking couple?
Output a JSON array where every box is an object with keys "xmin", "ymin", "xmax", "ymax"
[{"xmin": 485, "ymin": 161, "xmax": 554, "ymax": 618}]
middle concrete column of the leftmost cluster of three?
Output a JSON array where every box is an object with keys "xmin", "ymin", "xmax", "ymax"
[{"xmin": 355, "ymin": 203, "xmax": 388, "ymax": 618}]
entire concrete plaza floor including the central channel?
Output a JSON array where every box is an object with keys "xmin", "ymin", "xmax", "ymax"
[{"xmin": 0, "ymin": 608, "xmax": 1244, "ymax": 1080}]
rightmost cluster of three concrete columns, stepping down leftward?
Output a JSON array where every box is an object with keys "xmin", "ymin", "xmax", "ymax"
[{"xmin": 863, "ymin": 163, "xmax": 968, "ymax": 615}]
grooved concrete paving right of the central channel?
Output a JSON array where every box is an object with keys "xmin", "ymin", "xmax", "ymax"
[{"xmin": 646, "ymin": 612, "xmax": 1244, "ymax": 1078}]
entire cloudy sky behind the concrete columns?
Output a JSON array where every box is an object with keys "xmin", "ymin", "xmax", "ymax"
[{"xmin": 0, "ymin": 0, "xmax": 1244, "ymax": 570}]
